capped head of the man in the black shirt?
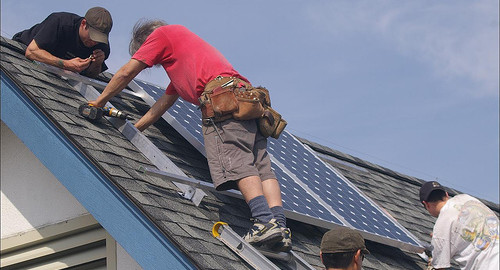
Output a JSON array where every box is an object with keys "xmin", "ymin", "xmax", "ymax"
[{"xmin": 79, "ymin": 7, "xmax": 113, "ymax": 48}]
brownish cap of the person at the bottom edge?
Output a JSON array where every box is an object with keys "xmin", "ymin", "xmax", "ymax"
[{"xmin": 321, "ymin": 227, "xmax": 370, "ymax": 254}]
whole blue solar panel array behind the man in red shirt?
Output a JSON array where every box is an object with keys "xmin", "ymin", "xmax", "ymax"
[{"xmin": 135, "ymin": 80, "xmax": 421, "ymax": 251}]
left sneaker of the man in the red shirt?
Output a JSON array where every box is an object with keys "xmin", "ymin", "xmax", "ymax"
[{"xmin": 243, "ymin": 218, "xmax": 283, "ymax": 246}]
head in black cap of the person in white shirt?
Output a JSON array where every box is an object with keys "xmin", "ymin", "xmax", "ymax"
[{"xmin": 419, "ymin": 181, "xmax": 449, "ymax": 217}]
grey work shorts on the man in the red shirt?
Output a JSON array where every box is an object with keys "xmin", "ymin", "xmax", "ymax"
[{"xmin": 203, "ymin": 118, "xmax": 276, "ymax": 190}]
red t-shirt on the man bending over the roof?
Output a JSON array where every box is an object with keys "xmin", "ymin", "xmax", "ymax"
[{"xmin": 132, "ymin": 25, "xmax": 248, "ymax": 105}]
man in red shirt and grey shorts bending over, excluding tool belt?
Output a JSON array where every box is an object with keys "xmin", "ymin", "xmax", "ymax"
[{"xmin": 90, "ymin": 21, "xmax": 291, "ymax": 251}]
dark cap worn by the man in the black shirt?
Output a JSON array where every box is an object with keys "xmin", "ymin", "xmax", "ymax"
[{"xmin": 85, "ymin": 7, "xmax": 113, "ymax": 44}]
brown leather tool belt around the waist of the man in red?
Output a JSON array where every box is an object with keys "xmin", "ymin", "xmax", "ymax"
[{"xmin": 199, "ymin": 76, "xmax": 287, "ymax": 139}]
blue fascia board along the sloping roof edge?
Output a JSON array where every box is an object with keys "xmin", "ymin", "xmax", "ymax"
[{"xmin": 0, "ymin": 71, "xmax": 196, "ymax": 269}]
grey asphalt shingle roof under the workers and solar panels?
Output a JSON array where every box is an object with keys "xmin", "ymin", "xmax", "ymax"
[{"xmin": 0, "ymin": 37, "xmax": 499, "ymax": 270}]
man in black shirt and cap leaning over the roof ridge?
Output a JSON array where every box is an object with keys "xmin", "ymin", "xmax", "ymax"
[{"xmin": 12, "ymin": 7, "xmax": 113, "ymax": 77}]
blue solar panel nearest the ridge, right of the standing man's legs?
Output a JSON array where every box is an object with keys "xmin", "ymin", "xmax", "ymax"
[{"xmin": 268, "ymin": 131, "xmax": 418, "ymax": 245}]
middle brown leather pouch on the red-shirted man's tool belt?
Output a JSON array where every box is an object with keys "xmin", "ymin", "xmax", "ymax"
[{"xmin": 233, "ymin": 88, "xmax": 264, "ymax": 120}]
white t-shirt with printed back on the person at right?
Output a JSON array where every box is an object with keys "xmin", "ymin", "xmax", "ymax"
[{"xmin": 431, "ymin": 194, "xmax": 500, "ymax": 270}]
